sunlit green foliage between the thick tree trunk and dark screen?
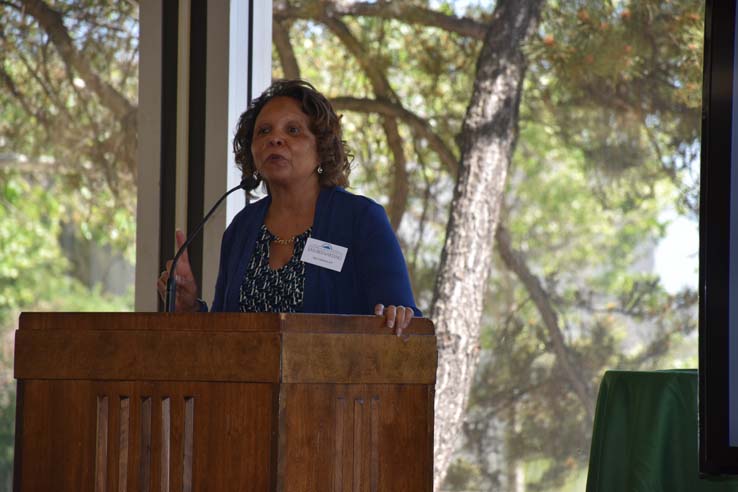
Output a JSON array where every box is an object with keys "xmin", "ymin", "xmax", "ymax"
[{"xmin": 454, "ymin": 2, "xmax": 702, "ymax": 482}]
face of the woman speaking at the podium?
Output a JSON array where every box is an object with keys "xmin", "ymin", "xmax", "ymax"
[{"xmin": 251, "ymin": 96, "xmax": 318, "ymax": 190}]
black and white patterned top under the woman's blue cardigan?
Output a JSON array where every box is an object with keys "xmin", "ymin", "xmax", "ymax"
[{"xmin": 240, "ymin": 224, "xmax": 312, "ymax": 313}]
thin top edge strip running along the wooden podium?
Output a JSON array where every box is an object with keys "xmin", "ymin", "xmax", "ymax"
[{"xmin": 19, "ymin": 312, "xmax": 435, "ymax": 335}]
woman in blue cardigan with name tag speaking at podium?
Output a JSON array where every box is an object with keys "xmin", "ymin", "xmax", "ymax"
[{"xmin": 158, "ymin": 80, "xmax": 421, "ymax": 334}]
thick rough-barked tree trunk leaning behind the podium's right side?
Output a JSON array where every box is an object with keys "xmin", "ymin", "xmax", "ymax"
[{"xmin": 431, "ymin": 0, "xmax": 542, "ymax": 490}]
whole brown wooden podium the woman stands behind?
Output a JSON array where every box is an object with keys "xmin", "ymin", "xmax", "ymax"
[{"xmin": 14, "ymin": 313, "xmax": 437, "ymax": 492}]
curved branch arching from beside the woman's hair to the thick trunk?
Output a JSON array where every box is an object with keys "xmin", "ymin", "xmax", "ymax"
[{"xmin": 331, "ymin": 96, "xmax": 459, "ymax": 176}]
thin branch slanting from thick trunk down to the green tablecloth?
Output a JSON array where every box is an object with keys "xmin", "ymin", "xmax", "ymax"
[{"xmin": 495, "ymin": 224, "xmax": 594, "ymax": 419}]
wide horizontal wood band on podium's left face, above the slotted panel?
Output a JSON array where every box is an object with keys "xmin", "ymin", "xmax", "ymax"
[{"xmin": 15, "ymin": 328, "xmax": 280, "ymax": 382}]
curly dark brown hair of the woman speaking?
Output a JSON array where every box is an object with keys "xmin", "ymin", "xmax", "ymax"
[{"xmin": 233, "ymin": 79, "xmax": 352, "ymax": 191}]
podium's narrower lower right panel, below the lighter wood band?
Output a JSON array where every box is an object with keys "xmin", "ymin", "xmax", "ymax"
[{"xmin": 277, "ymin": 384, "xmax": 434, "ymax": 492}]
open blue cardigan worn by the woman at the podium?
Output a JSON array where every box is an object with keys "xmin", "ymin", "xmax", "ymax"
[{"xmin": 211, "ymin": 187, "xmax": 422, "ymax": 316}]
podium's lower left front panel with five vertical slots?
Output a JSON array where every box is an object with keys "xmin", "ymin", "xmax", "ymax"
[{"xmin": 15, "ymin": 380, "xmax": 278, "ymax": 492}]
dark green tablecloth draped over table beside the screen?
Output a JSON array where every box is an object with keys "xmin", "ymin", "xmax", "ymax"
[{"xmin": 587, "ymin": 370, "xmax": 738, "ymax": 492}]
